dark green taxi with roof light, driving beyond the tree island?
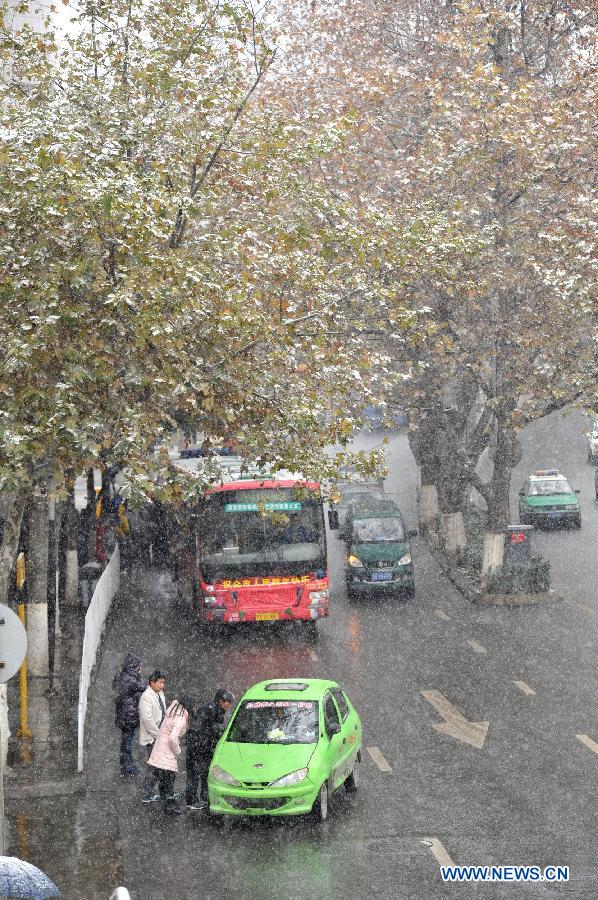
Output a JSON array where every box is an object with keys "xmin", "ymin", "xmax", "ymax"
[{"xmin": 519, "ymin": 469, "xmax": 581, "ymax": 528}]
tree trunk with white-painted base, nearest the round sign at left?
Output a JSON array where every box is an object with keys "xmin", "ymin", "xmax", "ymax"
[{"xmin": 27, "ymin": 485, "xmax": 49, "ymax": 676}]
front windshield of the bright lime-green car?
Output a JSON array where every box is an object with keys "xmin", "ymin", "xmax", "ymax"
[{"xmin": 226, "ymin": 700, "xmax": 318, "ymax": 744}]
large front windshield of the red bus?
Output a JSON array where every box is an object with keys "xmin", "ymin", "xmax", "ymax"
[{"xmin": 196, "ymin": 488, "xmax": 326, "ymax": 581}]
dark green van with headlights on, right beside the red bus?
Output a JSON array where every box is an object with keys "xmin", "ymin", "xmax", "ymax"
[{"xmin": 344, "ymin": 497, "xmax": 417, "ymax": 596}]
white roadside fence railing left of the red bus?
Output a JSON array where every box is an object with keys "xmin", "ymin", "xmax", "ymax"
[{"xmin": 77, "ymin": 544, "xmax": 120, "ymax": 772}]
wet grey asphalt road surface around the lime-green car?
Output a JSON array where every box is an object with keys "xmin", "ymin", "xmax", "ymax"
[{"xmin": 8, "ymin": 418, "xmax": 598, "ymax": 900}]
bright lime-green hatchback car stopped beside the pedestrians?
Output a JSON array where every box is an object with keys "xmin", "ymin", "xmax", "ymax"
[{"xmin": 208, "ymin": 678, "xmax": 362, "ymax": 821}]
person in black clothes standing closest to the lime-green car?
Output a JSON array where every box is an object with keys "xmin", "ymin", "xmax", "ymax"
[{"xmin": 185, "ymin": 689, "xmax": 235, "ymax": 810}]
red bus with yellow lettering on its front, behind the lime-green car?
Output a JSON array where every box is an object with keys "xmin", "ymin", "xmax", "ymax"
[{"xmin": 177, "ymin": 458, "xmax": 328, "ymax": 625}]
